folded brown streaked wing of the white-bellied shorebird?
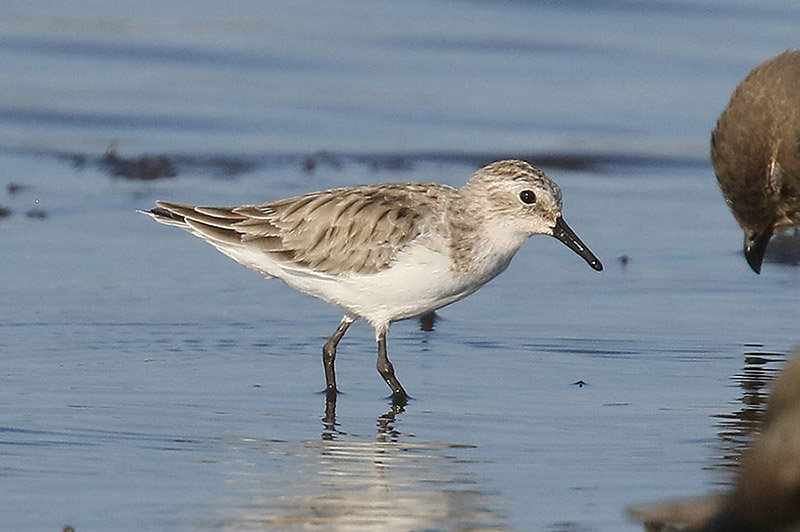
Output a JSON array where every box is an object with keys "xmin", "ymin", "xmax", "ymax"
[{"xmin": 231, "ymin": 183, "xmax": 455, "ymax": 275}]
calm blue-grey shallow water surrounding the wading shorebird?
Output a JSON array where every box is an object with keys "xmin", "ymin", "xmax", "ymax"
[{"xmin": 0, "ymin": 0, "xmax": 800, "ymax": 532}]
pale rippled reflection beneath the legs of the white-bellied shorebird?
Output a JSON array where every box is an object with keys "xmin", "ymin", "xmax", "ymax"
[{"xmin": 223, "ymin": 403, "xmax": 510, "ymax": 532}]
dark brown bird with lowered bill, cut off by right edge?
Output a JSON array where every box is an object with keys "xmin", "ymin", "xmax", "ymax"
[{"xmin": 711, "ymin": 51, "xmax": 800, "ymax": 273}]
